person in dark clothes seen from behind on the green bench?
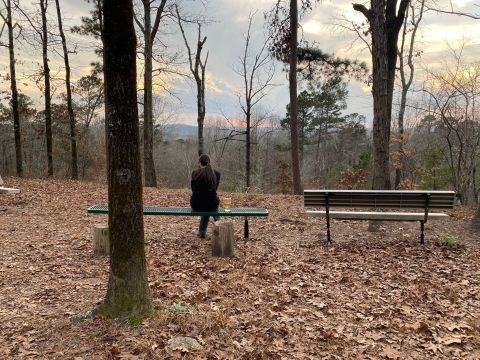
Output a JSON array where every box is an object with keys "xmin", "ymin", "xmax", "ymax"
[{"xmin": 190, "ymin": 154, "xmax": 220, "ymax": 239}]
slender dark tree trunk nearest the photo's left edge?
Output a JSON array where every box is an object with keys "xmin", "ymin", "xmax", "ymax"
[{"xmin": 7, "ymin": 0, "xmax": 24, "ymax": 177}]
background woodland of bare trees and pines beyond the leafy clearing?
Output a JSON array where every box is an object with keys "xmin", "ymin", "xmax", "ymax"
[{"xmin": 0, "ymin": 0, "xmax": 480, "ymax": 204}]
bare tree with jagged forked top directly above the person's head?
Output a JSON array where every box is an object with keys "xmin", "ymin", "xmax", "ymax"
[{"xmin": 175, "ymin": 6, "xmax": 208, "ymax": 156}]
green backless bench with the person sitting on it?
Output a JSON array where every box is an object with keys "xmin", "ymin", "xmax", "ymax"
[{"xmin": 87, "ymin": 205, "xmax": 268, "ymax": 240}]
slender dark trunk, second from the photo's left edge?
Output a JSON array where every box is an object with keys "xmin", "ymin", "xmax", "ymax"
[{"xmin": 40, "ymin": 0, "xmax": 53, "ymax": 176}]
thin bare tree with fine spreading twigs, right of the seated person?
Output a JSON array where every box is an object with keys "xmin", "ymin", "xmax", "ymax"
[{"xmin": 235, "ymin": 13, "xmax": 275, "ymax": 189}]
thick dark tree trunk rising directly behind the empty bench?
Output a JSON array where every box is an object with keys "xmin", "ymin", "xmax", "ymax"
[{"xmin": 370, "ymin": 0, "xmax": 391, "ymax": 190}]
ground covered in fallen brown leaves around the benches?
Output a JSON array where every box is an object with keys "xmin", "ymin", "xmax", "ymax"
[{"xmin": 0, "ymin": 178, "xmax": 480, "ymax": 360}]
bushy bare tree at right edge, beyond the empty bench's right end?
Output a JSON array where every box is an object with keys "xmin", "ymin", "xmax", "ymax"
[{"xmin": 423, "ymin": 47, "xmax": 480, "ymax": 202}]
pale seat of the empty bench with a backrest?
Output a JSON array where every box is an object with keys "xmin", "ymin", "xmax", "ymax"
[{"xmin": 306, "ymin": 210, "xmax": 449, "ymax": 221}]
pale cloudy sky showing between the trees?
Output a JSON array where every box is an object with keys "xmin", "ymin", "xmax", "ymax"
[{"xmin": 0, "ymin": 0, "xmax": 480, "ymax": 124}]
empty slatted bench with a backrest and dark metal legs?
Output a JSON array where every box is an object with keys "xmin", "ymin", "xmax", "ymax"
[{"xmin": 304, "ymin": 190, "xmax": 455, "ymax": 244}]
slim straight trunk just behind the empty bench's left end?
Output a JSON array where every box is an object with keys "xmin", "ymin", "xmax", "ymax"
[{"xmin": 288, "ymin": 0, "xmax": 302, "ymax": 194}]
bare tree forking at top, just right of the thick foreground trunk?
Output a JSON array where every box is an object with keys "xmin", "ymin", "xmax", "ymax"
[{"xmin": 134, "ymin": 0, "xmax": 167, "ymax": 187}]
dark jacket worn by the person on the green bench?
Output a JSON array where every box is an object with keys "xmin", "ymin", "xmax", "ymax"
[{"xmin": 190, "ymin": 170, "xmax": 220, "ymax": 211}]
